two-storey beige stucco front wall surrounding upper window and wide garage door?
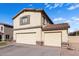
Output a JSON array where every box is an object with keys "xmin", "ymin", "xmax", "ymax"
[{"xmin": 13, "ymin": 12, "xmax": 42, "ymax": 43}]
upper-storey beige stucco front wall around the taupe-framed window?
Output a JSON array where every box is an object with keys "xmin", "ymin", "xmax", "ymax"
[{"xmin": 13, "ymin": 12, "xmax": 41, "ymax": 29}]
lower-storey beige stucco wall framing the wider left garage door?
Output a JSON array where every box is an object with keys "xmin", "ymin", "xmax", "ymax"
[{"xmin": 13, "ymin": 28, "xmax": 41, "ymax": 43}]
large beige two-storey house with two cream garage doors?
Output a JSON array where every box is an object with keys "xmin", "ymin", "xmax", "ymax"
[{"xmin": 13, "ymin": 9, "xmax": 69, "ymax": 47}]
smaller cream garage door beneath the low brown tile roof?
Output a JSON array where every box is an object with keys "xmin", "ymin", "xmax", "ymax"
[{"xmin": 44, "ymin": 33, "xmax": 61, "ymax": 46}]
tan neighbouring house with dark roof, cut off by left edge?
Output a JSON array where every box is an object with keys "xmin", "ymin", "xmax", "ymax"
[{"xmin": 0, "ymin": 23, "xmax": 13, "ymax": 41}]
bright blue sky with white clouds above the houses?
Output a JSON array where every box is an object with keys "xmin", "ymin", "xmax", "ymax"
[{"xmin": 0, "ymin": 3, "xmax": 79, "ymax": 32}]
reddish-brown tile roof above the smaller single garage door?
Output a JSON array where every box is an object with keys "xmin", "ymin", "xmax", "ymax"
[{"xmin": 43, "ymin": 23, "xmax": 70, "ymax": 31}]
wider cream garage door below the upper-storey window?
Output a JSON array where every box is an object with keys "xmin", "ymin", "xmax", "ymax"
[{"xmin": 17, "ymin": 33, "xmax": 36, "ymax": 44}]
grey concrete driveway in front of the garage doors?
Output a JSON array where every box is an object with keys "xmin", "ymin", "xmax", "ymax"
[{"xmin": 0, "ymin": 44, "xmax": 61, "ymax": 56}]
